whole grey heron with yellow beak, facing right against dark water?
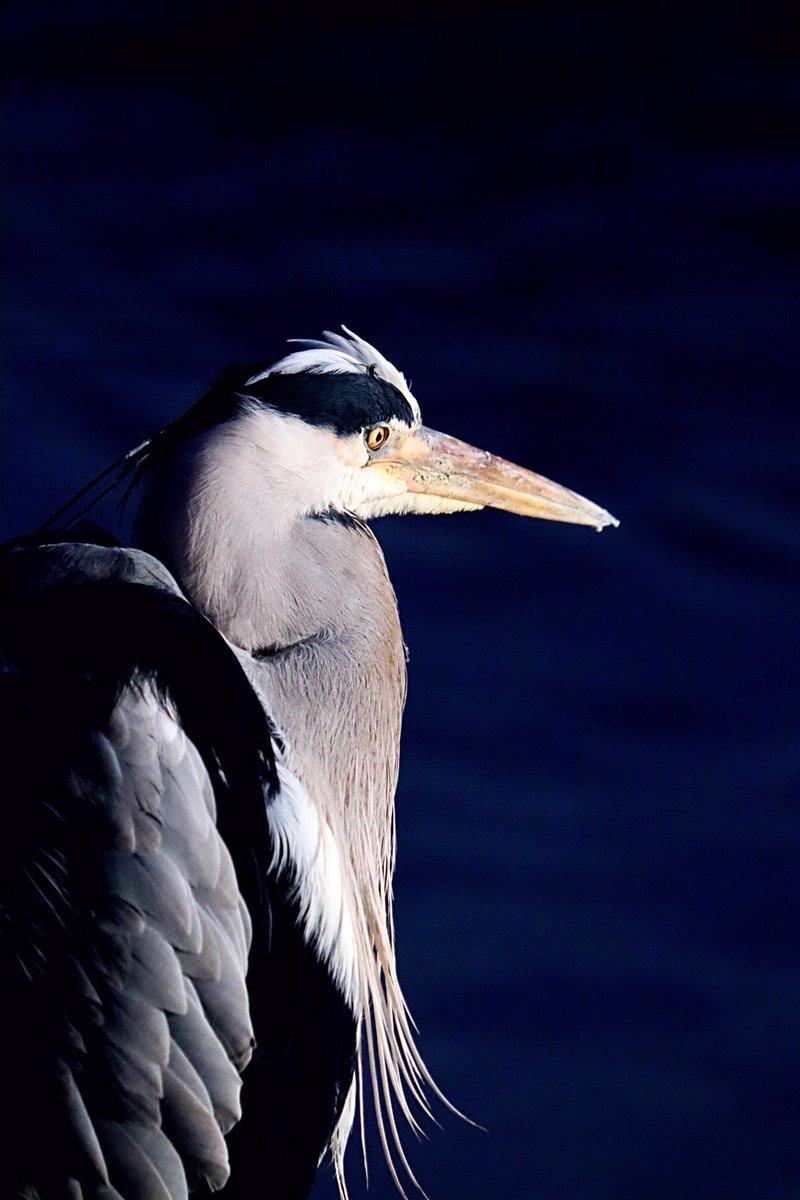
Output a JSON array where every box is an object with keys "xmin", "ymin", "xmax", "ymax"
[{"xmin": 0, "ymin": 326, "xmax": 616, "ymax": 1200}]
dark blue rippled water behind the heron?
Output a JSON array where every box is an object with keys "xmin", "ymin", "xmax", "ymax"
[{"xmin": 2, "ymin": 0, "xmax": 800, "ymax": 1200}]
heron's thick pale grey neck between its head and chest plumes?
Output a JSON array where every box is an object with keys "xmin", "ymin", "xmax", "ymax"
[{"xmin": 136, "ymin": 432, "xmax": 405, "ymax": 853}]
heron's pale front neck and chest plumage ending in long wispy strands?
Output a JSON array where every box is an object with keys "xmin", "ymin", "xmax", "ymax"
[{"xmin": 247, "ymin": 532, "xmax": 448, "ymax": 1192}]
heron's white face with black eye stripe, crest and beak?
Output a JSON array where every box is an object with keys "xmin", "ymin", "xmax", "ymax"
[{"xmin": 237, "ymin": 330, "xmax": 616, "ymax": 529}]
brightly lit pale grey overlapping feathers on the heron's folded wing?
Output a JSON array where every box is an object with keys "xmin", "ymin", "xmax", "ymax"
[{"xmin": 65, "ymin": 690, "xmax": 252, "ymax": 1200}]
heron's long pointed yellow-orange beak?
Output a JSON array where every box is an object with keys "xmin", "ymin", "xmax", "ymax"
[{"xmin": 384, "ymin": 426, "xmax": 619, "ymax": 530}]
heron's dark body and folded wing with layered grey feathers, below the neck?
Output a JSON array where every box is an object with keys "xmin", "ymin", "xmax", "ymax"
[{"xmin": 0, "ymin": 545, "xmax": 356, "ymax": 1200}]
